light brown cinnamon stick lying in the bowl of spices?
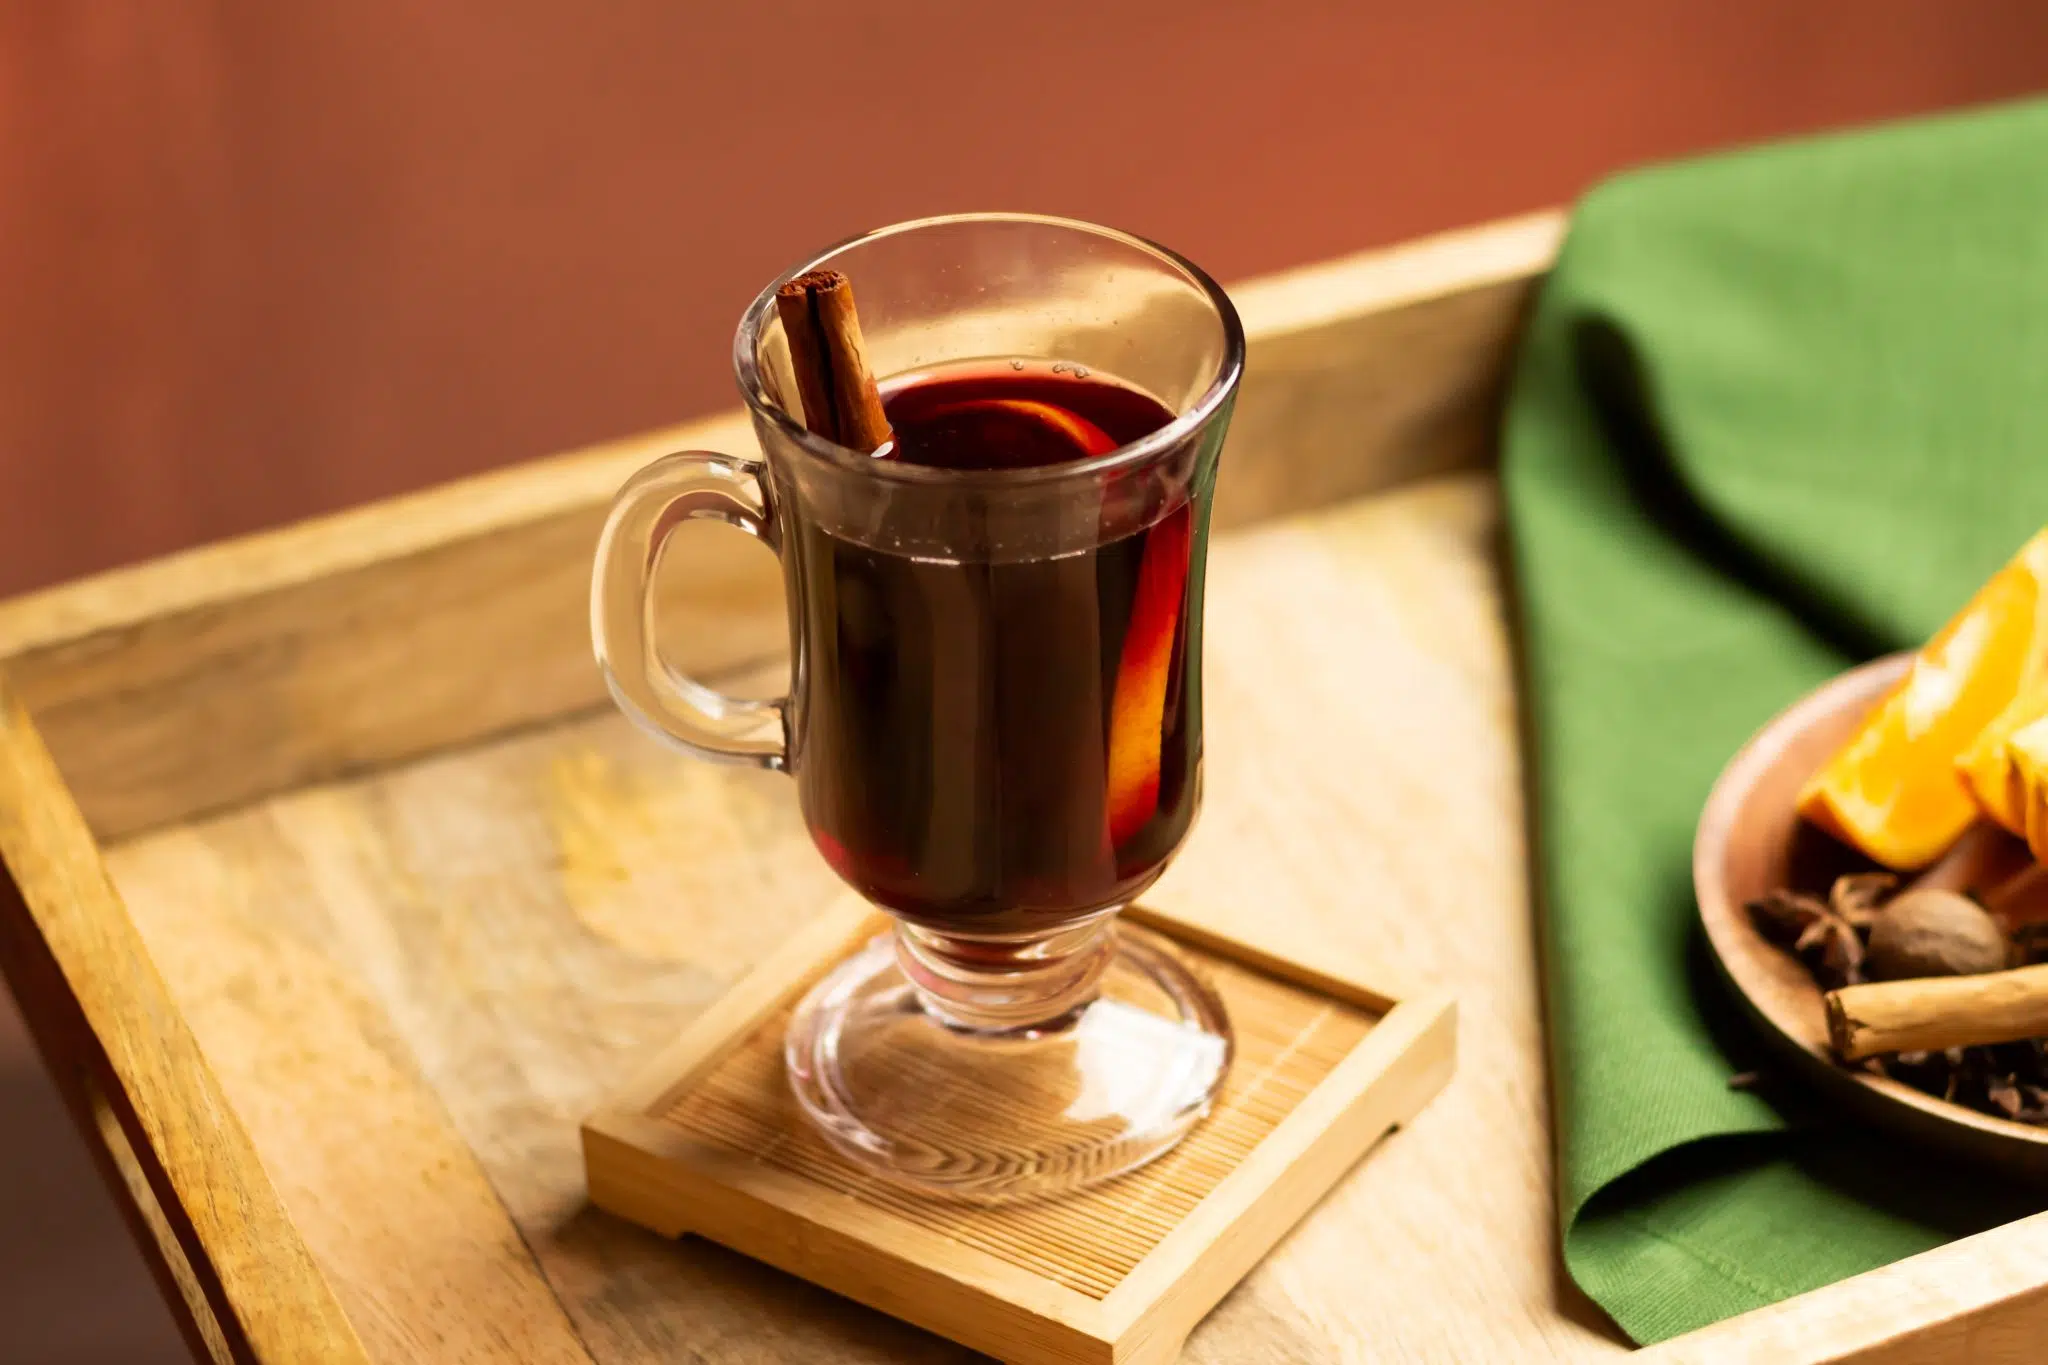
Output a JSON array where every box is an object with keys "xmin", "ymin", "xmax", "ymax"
[{"xmin": 1827, "ymin": 964, "xmax": 2048, "ymax": 1062}]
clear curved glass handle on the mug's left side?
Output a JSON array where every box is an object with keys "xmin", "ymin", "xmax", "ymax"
[{"xmin": 590, "ymin": 450, "xmax": 788, "ymax": 769}]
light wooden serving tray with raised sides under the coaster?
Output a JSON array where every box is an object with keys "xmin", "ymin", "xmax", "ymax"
[{"xmin": 0, "ymin": 205, "xmax": 2048, "ymax": 1365}]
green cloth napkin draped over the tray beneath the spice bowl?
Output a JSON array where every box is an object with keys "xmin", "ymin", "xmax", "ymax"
[{"xmin": 1503, "ymin": 102, "xmax": 2048, "ymax": 1342}]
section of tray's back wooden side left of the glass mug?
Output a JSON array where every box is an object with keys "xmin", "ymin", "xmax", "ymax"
[{"xmin": 0, "ymin": 417, "xmax": 784, "ymax": 837}]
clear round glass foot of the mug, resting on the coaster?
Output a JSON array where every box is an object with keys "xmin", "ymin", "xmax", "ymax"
[{"xmin": 782, "ymin": 915, "xmax": 1231, "ymax": 1203}]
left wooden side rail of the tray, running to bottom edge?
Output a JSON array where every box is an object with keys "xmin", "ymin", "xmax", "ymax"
[{"xmin": 0, "ymin": 681, "xmax": 365, "ymax": 1365}]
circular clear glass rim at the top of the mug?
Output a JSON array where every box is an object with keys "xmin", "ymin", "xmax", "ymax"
[{"xmin": 733, "ymin": 213, "xmax": 1245, "ymax": 487}]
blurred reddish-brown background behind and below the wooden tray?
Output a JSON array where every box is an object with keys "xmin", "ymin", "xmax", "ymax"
[{"xmin": 0, "ymin": 0, "xmax": 2048, "ymax": 1363}]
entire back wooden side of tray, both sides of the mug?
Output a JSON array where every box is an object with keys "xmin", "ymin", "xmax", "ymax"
[{"xmin": 0, "ymin": 213, "xmax": 1563, "ymax": 837}]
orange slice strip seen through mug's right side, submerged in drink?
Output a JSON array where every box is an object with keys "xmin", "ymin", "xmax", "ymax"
[{"xmin": 1106, "ymin": 503, "xmax": 1194, "ymax": 847}]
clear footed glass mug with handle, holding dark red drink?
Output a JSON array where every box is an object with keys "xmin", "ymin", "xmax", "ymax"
[{"xmin": 592, "ymin": 215, "xmax": 1245, "ymax": 1199}]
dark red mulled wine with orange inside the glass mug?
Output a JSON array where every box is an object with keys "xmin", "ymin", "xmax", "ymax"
[{"xmin": 791, "ymin": 360, "xmax": 1202, "ymax": 933}]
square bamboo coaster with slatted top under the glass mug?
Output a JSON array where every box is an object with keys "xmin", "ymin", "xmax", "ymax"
[{"xmin": 584, "ymin": 905, "xmax": 1456, "ymax": 1365}]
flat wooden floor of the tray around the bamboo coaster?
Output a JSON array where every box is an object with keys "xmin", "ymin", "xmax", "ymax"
[{"xmin": 88, "ymin": 475, "xmax": 1618, "ymax": 1365}]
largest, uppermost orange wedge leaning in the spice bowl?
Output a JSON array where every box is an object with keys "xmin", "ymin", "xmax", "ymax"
[{"xmin": 1798, "ymin": 532, "xmax": 2048, "ymax": 870}]
